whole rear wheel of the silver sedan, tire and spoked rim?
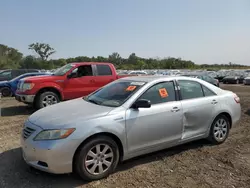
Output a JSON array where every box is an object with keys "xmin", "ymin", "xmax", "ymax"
[{"xmin": 209, "ymin": 115, "xmax": 230, "ymax": 144}]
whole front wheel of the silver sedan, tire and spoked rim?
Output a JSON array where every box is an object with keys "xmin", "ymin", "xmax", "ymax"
[{"xmin": 74, "ymin": 136, "xmax": 119, "ymax": 181}]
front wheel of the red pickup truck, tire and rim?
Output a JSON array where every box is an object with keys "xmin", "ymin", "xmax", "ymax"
[{"xmin": 35, "ymin": 91, "xmax": 60, "ymax": 109}]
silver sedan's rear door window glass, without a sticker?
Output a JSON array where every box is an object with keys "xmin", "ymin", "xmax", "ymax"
[{"xmin": 178, "ymin": 80, "xmax": 204, "ymax": 100}]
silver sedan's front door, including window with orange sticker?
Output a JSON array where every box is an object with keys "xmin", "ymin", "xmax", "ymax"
[{"xmin": 126, "ymin": 82, "xmax": 182, "ymax": 152}]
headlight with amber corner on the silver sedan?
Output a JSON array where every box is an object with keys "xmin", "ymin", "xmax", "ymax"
[{"xmin": 34, "ymin": 128, "xmax": 75, "ymax": 141}]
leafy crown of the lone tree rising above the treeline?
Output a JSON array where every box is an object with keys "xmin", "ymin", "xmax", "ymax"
[{"xmin": 29, "ymin": 42, "xmax": 56, "ymax": 61}]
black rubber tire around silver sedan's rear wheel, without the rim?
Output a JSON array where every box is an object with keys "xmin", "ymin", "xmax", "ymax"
[{"xmin": 208, "ymin": 115, "xmax": 230, "ymax": 145}]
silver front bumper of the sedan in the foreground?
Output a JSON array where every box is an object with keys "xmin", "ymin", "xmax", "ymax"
[{"xmin": 21, "ymin": 121, "xmax": 79, "ymax": 174}]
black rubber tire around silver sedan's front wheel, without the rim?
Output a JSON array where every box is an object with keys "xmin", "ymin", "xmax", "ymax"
[{"xmin": 74, "ymin": 136, "xmax": 120, "ymax": 181}]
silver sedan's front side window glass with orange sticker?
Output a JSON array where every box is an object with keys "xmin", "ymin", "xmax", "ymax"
[{"xmin": 139, "ymin": 82, "xmax": 176, "ymax": 104}]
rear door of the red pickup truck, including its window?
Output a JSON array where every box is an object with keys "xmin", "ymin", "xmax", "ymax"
[{"xmin": 94, "ymin": 64, "xmax": 115, "ymax": 89}]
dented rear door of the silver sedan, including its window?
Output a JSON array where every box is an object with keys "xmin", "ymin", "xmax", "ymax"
[{"xmin": 178, "ymin": 80, "xmax": 219, "ymax": 140}]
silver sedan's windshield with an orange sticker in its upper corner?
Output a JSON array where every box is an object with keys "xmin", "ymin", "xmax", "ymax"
[{"xmin": 84, "ymin": 81, "xmax": 146, "ymax": 107}]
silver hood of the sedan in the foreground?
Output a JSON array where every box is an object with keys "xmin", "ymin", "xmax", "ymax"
[{"xmin": 28, "ymin": 98, "xmax": 114, "ymax": 129}]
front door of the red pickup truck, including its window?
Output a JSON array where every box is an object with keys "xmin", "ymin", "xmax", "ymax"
[{"xmin": 63, "ymin": 64, "xmax": 96, "ymax": 99}]
